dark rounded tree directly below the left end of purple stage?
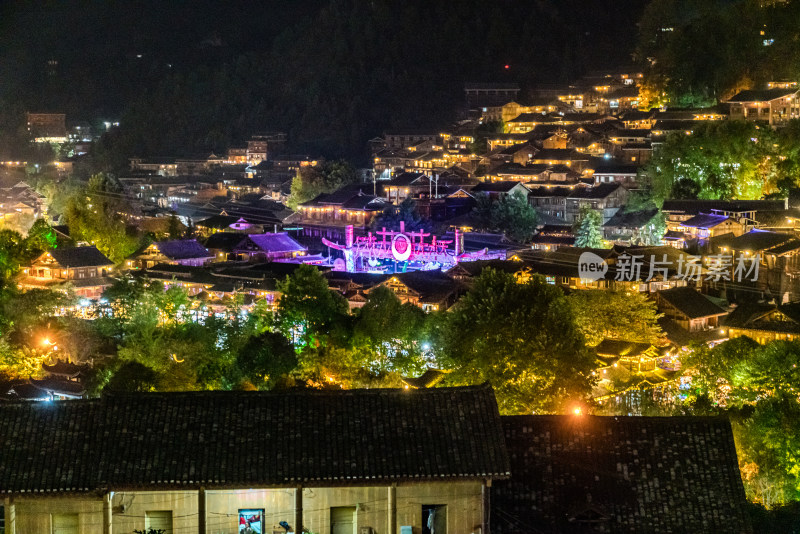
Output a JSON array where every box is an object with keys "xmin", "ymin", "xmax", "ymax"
[{"xmin": 275, "ymin": 265, "xmax": 348, "ymax": 349}]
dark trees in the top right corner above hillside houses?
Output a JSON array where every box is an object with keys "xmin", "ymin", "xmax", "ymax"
[{"xmin": 635, "ymin": 0, "xmax": 800, "ymax": 109}]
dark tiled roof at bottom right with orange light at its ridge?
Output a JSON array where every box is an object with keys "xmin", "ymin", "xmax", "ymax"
[{"xmin": 491, "ymin": 416, "xmax": 751, "ymax": 534}]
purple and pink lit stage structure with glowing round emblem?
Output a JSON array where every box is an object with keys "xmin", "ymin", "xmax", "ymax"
[{"xmin": 322, "ymin": 221, "xmax": 506, "ymax": 273}]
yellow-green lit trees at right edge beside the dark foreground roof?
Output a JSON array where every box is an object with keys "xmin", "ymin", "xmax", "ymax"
[{"xmin": 683, "ymin": 338, "xmax": 800, "ymax": 508}]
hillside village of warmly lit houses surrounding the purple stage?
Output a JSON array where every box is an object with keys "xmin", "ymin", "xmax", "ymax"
[{"xmin": 12, "ymin": 70, "xmax": 800, "ymax": 413}]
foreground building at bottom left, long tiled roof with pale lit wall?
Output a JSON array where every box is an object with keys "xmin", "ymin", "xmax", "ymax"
[{"xmin": 0, "ymin": 386, "xmax": 509, "ymax": 534}]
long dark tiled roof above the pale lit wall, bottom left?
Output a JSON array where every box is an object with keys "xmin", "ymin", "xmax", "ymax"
[{"xmin": 0, "ymin": 385, "xmax": 509, "ymax": 493}]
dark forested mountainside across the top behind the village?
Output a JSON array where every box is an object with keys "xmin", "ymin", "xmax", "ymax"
[{"xmin": 0, "ymin": 0, "xmax": 646, "ymax": 164}]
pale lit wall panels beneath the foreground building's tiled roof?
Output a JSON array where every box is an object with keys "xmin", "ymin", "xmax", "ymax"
[{"xmin": 7, "ymin": 482, "xmax": 483, "ymax": 534}]
